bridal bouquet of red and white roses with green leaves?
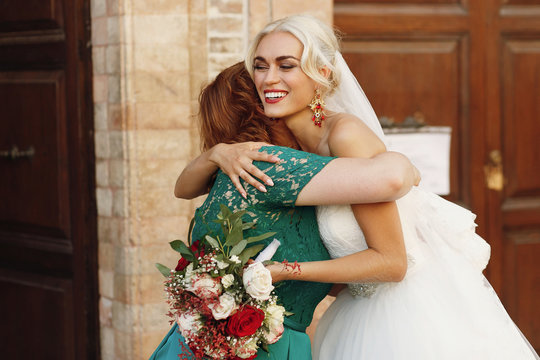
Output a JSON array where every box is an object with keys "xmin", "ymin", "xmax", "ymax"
[{"xmin": 156, "ymin": 205, "xmax": 285, "ymax": 359}]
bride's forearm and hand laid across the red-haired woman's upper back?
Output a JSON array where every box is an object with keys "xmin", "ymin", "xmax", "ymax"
[{"xmin": 174, "ymin": 142, "xmax": 279, "ymax": 199}]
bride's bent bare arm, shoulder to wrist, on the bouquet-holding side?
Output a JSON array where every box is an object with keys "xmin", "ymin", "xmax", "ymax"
[{"xmin": 276, "ymin": 116, "xmax": 407, "ymax": 283}]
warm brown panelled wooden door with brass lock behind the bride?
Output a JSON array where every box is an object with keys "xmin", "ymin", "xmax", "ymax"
[{"xmin": 334, "ymin": 0, "xmax": 540, "ymax": 349}]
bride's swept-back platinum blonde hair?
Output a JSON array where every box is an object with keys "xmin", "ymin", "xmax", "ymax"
[{"xmin": 245, "ymin": 15, "xmax": 339, "ymax": 93}]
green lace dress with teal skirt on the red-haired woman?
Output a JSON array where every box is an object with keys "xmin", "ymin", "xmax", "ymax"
[{"xmin": 150, "ymin": 146, "xmax": 332, "ymax": 360}]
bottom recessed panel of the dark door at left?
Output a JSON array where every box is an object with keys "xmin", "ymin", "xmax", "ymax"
[{"xmin": 0, "ymin": 269, "xmax": 76, "ymax": 360}]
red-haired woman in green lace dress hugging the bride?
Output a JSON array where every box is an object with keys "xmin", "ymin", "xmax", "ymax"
[{"xmin": 150, "ymin": 64, "xmax": 417, "ymax": 360}]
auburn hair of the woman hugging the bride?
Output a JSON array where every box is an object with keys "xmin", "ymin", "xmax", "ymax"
[{"xmin": 199, "ymin": 62, "xmax": 300, "ymax": 151}]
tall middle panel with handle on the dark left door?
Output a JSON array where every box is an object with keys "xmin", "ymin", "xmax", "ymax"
[{"xmin": 0, "ymin": 71, "xmax": 70, "ymax": 238}]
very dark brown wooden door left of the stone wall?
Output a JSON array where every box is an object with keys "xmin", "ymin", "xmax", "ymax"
[{"xmin": 0, "ymin": 0, "xmax": 99, "ymax": 360}]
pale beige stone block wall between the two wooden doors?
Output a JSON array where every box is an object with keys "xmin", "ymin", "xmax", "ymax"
[{"xmin": 91, "ymin": 0, "xmax": 332, "ymax": 360}]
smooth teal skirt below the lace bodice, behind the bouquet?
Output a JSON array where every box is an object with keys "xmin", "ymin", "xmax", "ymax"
[{"xmin": 150, "ymin": 318, "xmax": 311, "ymax": 360}]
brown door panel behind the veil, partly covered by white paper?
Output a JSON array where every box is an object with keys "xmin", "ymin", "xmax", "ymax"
[{"xmin": 342, "ymin": 35, "xmax": 469, "ymax": 204}]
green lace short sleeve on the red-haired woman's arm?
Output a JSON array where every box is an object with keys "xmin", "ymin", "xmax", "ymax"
[{"xmin": 247, "ymin": 146, "xmax": 334, "ymax": 207}]
